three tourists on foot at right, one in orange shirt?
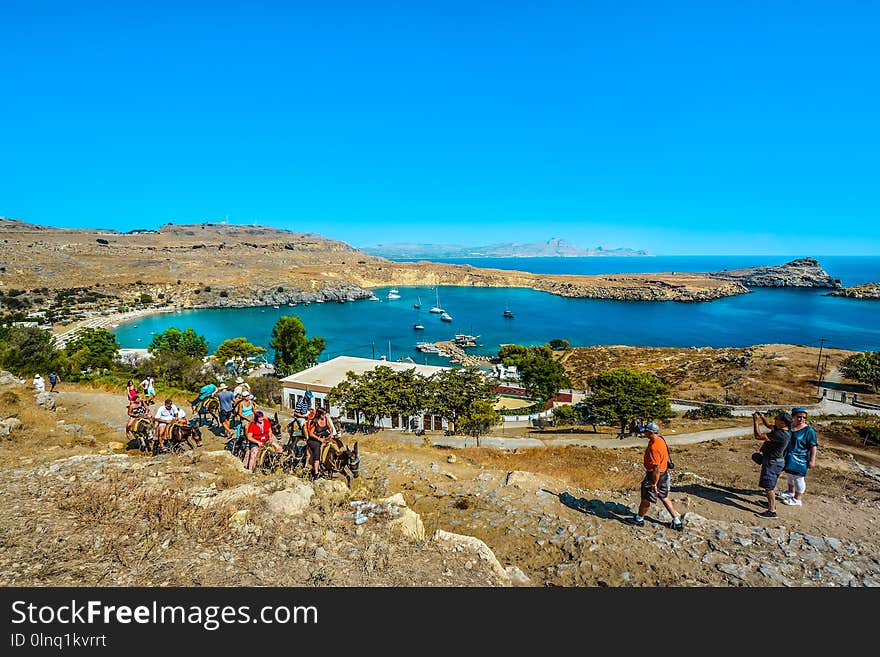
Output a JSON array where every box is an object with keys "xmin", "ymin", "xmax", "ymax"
[{"xmin": 627, "ymin": 406, "xmax": 819, "ymax": 531}]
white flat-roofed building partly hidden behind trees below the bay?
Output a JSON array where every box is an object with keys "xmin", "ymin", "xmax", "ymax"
[{"xmin": 281, "ymin": 356, "xmax": 452, "ymax": 431}]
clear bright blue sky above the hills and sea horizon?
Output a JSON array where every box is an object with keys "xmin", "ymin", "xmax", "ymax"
[{"xmin": 0, "ymin": 0, "xmax": 880, "ymax": 255}]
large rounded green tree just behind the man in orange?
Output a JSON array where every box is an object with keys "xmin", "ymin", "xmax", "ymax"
[{"xmin": 589, "ymin": 367, "xmax": 672, "ymax": 435}]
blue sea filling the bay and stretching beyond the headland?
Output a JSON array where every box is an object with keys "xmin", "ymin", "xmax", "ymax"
[{"xmin": 114, "ymin": 255, "xmax": 880, "ymax": 365}]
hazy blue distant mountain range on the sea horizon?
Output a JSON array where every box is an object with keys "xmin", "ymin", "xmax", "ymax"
[{"xmin": 359, "ymin": 238, "xmax": 650, "ymax": 259}]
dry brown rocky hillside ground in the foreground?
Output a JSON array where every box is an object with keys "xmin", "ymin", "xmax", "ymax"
[{"xmin": 0, "ymin": 382, "xmax": 880, "ymax": 586}]
